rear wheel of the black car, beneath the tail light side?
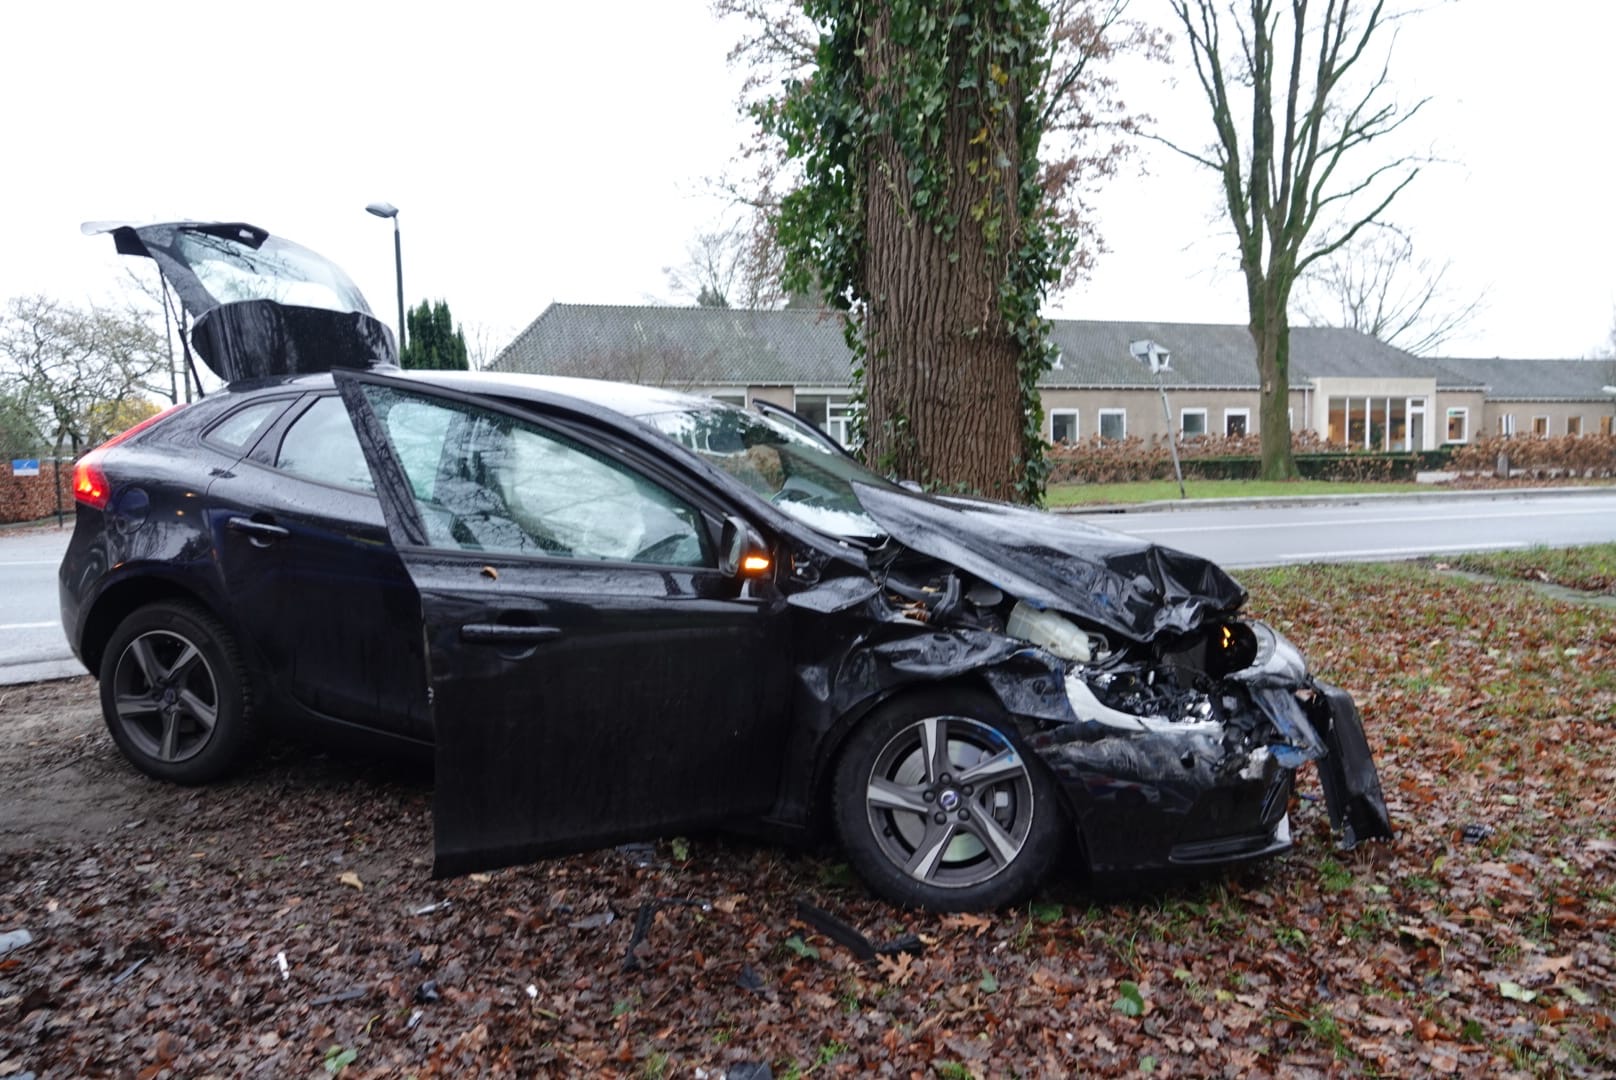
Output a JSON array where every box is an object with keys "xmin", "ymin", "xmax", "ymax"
[{"xmin": 100, "ymin": 603, "xmax": 252, "ymax": 784}]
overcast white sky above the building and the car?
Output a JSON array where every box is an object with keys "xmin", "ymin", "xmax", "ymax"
[{"xmin": 0, "ymin": 0, "xmax": 1616, "ymax": 357}]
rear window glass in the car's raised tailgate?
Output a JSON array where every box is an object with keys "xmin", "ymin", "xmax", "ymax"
[{"xmin": 173, "ymin": 228, "xmax": 370, "ymax": 315}]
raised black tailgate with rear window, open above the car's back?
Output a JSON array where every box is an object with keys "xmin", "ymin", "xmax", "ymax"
[{"xmin": 84, "ymin": 221, "xmax": 398, "ymax": 383}]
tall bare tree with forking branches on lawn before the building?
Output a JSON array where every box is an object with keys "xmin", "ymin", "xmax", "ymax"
[{"xmin": 1154, "ymin": 0, "xmax": 1424, "ymax": 480}]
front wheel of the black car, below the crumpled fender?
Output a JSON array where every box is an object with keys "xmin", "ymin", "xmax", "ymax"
[{"xmin": 831, "ymin": 690, "xmax": 1067, "ymax": 912}]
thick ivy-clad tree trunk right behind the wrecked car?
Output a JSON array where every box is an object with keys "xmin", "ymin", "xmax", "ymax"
[{"xmin": 760, "ymin": 0, "xmax": 1073, "ymax": 501}]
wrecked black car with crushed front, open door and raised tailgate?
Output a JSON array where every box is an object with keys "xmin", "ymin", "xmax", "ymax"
[{"xmin": 60, "ymin": 223, "xmax": 1391, "ymax": 910}]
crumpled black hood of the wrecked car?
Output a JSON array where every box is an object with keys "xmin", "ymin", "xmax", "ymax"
[{"xmin": 855, "ymin": 483, "xmax": 1246, "ymax": 642}]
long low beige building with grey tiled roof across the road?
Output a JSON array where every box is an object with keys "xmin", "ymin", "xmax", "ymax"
[{"xmin": 491, "ymin": 304, "xmax": 1616, "ymax": 451}]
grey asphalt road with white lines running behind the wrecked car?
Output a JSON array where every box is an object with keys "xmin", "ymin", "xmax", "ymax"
[{"xmin": 0, "ymin": 488, "xmax": 1616, "ymax": 686}]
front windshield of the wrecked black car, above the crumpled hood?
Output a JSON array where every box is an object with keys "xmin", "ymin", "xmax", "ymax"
[{"xmin": 640, "ymin": 403, "xmax": 890, "ymax": 540}]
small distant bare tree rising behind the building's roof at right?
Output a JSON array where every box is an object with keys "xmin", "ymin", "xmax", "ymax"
[{"xmin": 1296, "ymin": 226, "xmax": 1482, "ymax": 356}]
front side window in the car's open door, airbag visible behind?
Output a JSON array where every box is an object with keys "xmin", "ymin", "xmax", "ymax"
[{"xmin": 365, "ymin": 386, "xmax": 713, "ymax": 566}]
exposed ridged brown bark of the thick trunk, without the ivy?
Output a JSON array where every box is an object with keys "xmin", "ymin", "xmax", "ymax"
[{"xmin": 863, "ymin": 5, "xmax": 1023, "ymax": 500}]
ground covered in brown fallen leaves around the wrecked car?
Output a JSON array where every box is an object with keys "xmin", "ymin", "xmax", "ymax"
[{"xmin": 0, "ymin": 566, "xmax": 1616, "ymax": 1077}]
